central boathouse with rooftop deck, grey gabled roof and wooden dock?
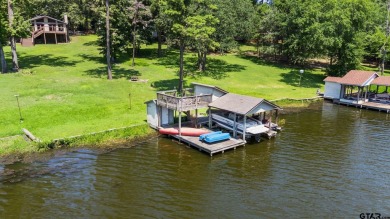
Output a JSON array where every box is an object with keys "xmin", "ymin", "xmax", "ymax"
[{"xmin": 146, "ymin": 83, "xmax": 280, "ymax": 156}]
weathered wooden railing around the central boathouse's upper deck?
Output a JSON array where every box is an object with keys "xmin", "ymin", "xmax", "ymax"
[{"xmin": 157, "ymin": 92, "xmax": 212, "ymax": 112}]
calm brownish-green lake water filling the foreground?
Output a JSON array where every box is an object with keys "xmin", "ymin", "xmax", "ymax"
[{"xmin": 0, "ymin": 102, "xmax": 390, "ymax": 218}]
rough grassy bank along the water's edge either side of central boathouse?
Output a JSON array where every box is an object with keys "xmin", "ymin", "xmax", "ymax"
[{"xmin": 0, "ymin": 99, "xmax": 323, "ymax": 164}]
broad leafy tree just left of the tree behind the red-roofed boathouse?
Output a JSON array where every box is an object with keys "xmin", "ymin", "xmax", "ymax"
[{"xmin": 271, "ymin": 0, "xmax": 333, "ymax": 64}]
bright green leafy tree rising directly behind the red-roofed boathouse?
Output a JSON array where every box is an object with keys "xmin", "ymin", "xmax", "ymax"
[{"xmin": 327, "ymin": 0, "xmax": 376, "ymax": 76}]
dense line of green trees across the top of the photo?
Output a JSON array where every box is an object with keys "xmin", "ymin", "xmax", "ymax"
[{"xmin": 0, "ymin": 0, "xmax": 389, "ymax": 80}]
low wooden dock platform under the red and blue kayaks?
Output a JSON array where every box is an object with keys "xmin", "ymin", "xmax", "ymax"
[{"xmin": 171, "ymin": 135, "xmax": 246, "ymax": 156}]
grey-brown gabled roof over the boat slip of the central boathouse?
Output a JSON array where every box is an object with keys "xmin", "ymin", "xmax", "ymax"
[{"xmin": 209, "ymin": 93, "xmax": 280, "ymax": 115}]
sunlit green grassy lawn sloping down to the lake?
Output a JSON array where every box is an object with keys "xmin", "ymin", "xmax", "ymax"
[{"xmin": 0, "ymin": 35, "xmax": 324, "ymax": 153}]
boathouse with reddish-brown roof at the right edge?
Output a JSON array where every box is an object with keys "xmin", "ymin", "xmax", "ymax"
[{"xmin": 324, "ymin": 70, "xmax": 390, "ymax": 113}]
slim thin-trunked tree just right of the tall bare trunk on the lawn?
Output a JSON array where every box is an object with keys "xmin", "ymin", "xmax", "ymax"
[{"xmin": 128, "ymin": 0, "xmax": 152, "ymax": 66}]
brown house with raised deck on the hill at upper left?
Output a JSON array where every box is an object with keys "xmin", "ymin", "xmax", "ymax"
[{"xmin": 21, "ymin": 15, "xmax": 69, "ymax": 46}]
